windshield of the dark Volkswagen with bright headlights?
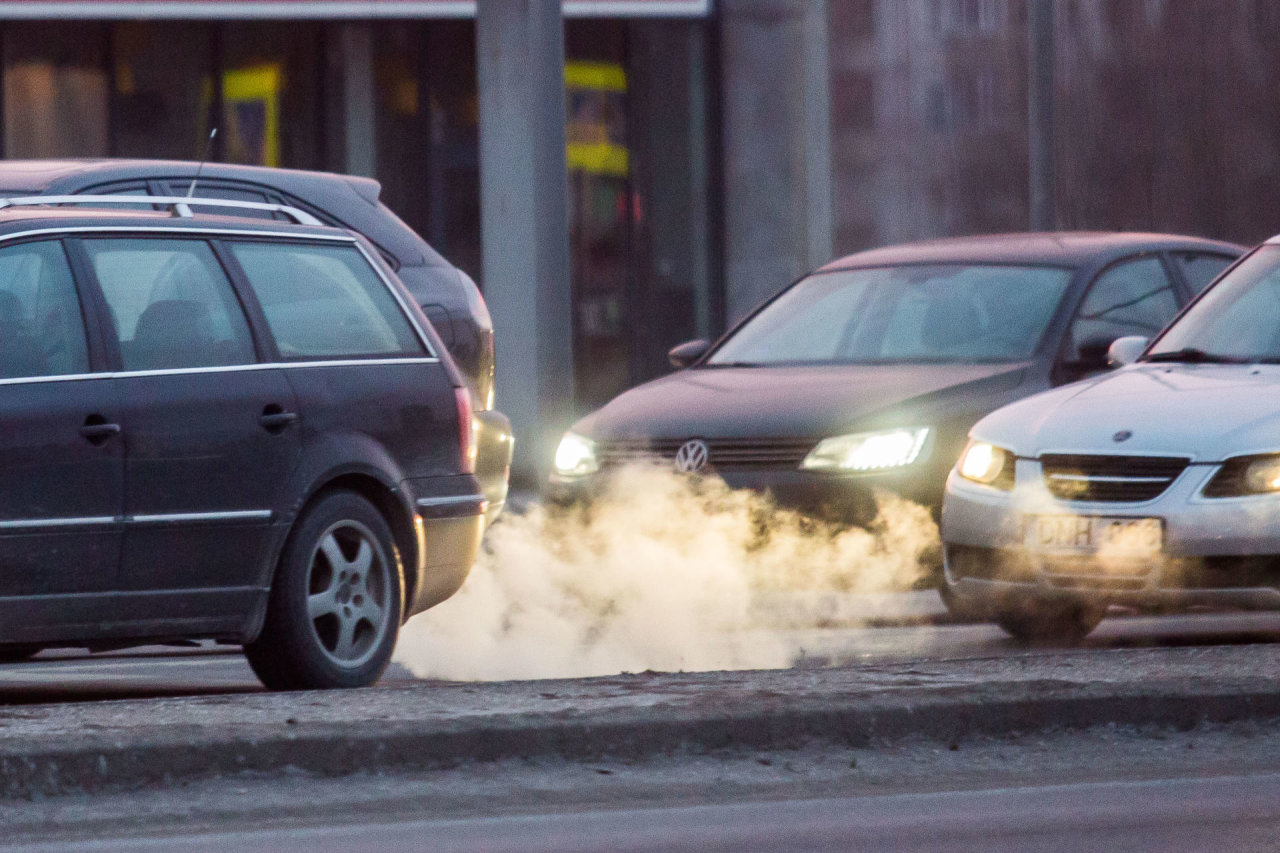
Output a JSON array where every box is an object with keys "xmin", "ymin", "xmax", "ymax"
[{"xmin": 707, "ymin": 264, "xmax": 1071, "ymax": 366}]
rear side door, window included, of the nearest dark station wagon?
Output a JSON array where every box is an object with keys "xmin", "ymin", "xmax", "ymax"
[{"xmin": 78, "ymin": 234, "xmax": 300, "ymax": 617}]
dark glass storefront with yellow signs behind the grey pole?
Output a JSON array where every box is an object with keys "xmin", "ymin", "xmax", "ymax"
[{"xmin": 0, "ymin": 12, "xmax": 722, "ymax": 422}]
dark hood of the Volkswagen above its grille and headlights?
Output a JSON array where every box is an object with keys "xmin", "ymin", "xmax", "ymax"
[{"xmin": 573, "ymin": 364, "xmax": 1027, "ymax": 439}]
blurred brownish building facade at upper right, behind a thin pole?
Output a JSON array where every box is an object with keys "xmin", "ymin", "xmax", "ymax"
[{"xmin": 827, "ymin": 0, "xmax": 1280, "ymax": 252}]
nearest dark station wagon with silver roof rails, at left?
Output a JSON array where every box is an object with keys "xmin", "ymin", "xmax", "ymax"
[{"xmin": 0, "ymin": 197, "xmax": 486, "ymax": 689}]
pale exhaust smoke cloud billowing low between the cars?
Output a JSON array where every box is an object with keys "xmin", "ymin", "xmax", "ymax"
[{"xmin": 396, "ymin": 466, "xmax": 938, "ymax": 680}]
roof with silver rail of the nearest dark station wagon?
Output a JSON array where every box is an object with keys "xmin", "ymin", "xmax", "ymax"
[{"xmin": 0, "ymin": 205, "xmax": 353, "ymax": 240}]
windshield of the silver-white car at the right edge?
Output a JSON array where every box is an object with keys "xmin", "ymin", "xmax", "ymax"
[{"xmin": 1144, "ymin": 246, "xmax": 1280, "ymax": 362}]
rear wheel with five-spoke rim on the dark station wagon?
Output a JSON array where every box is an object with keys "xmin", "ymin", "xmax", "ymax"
[{"xmin": 244, "ymin": 491, "xmax": 404, "ymax": 690}]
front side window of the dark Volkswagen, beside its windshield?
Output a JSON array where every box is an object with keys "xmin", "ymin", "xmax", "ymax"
[{"xmin": 1065, "ymin": 257, "xmax": 1179, "ymax": 361}]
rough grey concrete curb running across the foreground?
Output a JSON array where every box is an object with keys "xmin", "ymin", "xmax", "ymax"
[{"xmin": 0, "ymin": 679, "xmax": 1280, "ymax": 798}]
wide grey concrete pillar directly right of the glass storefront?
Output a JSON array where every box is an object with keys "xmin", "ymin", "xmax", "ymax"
[{"xmin": 719, "ymin": 0, "xmax": 832, "ymax": 323}]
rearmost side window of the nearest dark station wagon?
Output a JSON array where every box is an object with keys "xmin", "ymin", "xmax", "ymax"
[{"xmin": 232, "ymin": 242, "xmax": 425, "ymax": 359}]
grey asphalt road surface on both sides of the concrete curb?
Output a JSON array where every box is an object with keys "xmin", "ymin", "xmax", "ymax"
[{"xmin": 0, "ymin": 604, "xmax": 1280, "ymax": 853}]
